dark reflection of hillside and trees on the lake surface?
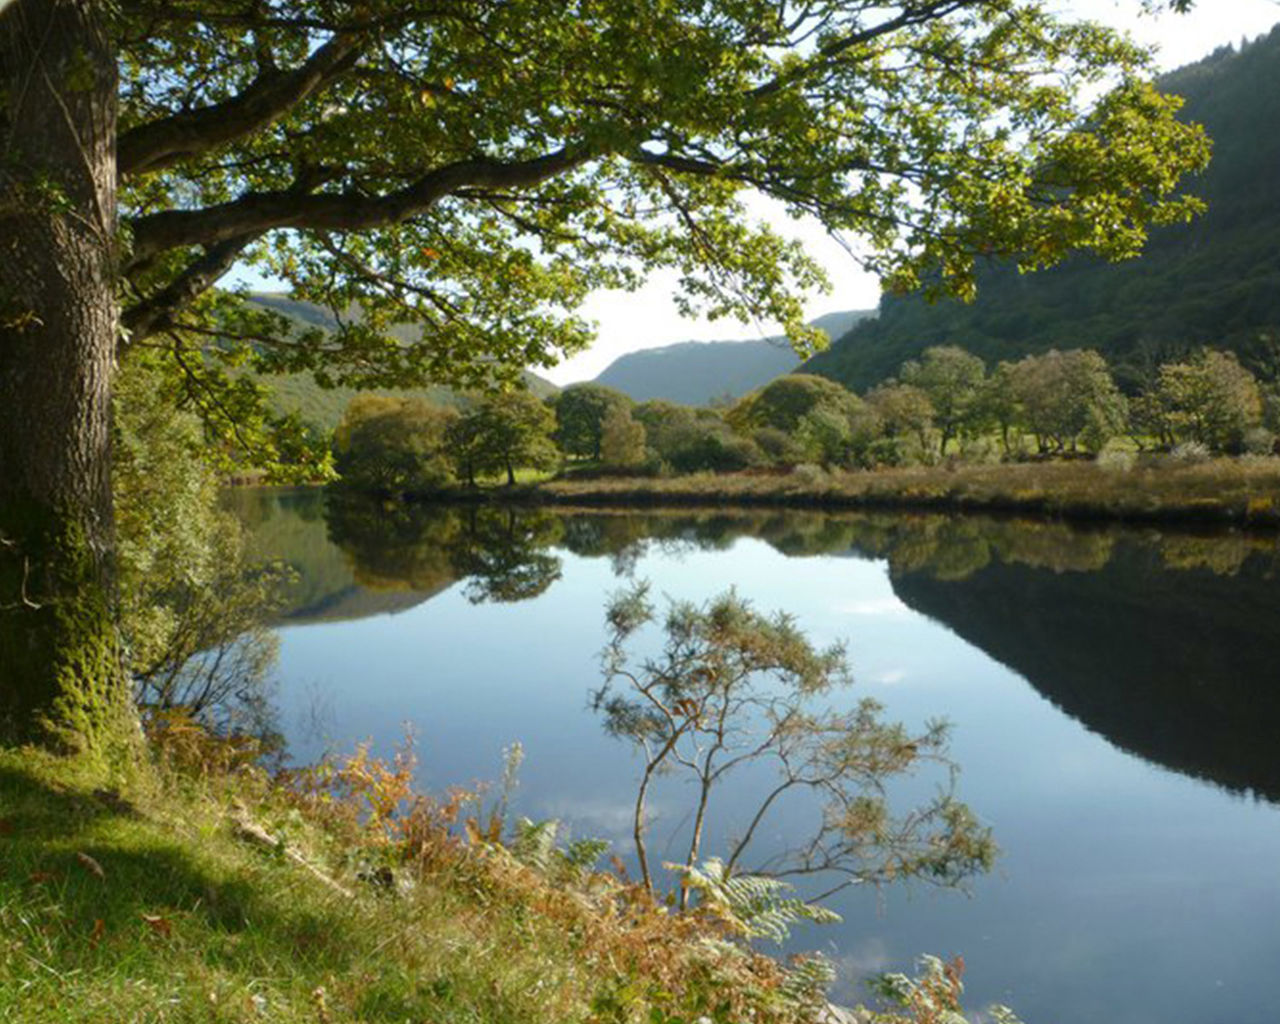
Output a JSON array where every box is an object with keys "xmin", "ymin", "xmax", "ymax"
[{"xmin": 234, "ymin": 492, "xmax": 1280, "ymax": 801}]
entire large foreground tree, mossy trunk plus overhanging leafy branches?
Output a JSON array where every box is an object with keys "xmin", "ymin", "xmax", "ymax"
[{"xmin": 0, "ymin": 0, "xmax": 1206, "ymax": 739}]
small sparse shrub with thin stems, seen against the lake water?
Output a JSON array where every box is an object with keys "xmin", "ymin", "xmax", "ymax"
[{"xmin": 593, "ymin": 585, "xmax": 995, "ymax": 901}]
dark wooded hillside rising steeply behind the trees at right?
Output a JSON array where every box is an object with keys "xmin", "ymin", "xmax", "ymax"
[{"xmin": 805, "ymin": 27, "xmax": 1280, "ymax": 390}]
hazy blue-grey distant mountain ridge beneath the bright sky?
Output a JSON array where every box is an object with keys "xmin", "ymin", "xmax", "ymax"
[{"xmin": 595, "ymin": 310, "xmax": 876, "ymax": 406}]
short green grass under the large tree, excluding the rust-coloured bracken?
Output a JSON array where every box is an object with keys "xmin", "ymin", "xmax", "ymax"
[{"xmin": 0, "ymin": 751, "xmax": 627, "ymax": 1024}]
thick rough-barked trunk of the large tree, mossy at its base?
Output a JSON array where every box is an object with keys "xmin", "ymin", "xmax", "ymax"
[{"xmin": 0, "ymin": 0, "xmax": 129, "ymax": 749}]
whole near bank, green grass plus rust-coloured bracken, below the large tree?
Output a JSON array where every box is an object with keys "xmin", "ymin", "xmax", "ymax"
[{"xmin": 0, "ymin": 731, "xmax": 899, "ymax": 1024}]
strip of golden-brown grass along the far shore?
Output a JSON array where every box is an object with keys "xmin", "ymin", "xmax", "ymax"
[{"xmin": 514, "ymin": 458, "xmax": 1280, "ymax": 529}]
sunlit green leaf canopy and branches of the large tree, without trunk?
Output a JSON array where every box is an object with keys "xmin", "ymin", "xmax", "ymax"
[{"xmin": 113, "ymin": 0, "xmax": 1207, "ymax": 407}]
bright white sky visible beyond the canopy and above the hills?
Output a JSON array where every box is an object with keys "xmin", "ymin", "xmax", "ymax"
[{"xmin": 541, "ymin": 0, "xmax": 1280, "ymax": 384}]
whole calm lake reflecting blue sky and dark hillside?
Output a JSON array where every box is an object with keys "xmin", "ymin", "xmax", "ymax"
[{"xmin": 230, "ymin": 490, "xmax": 1280, "ymax": 1024}]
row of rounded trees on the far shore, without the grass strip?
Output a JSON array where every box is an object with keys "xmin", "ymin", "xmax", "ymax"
[{"xmin": 333, "ymin": 346, "xmax": 1280, "ymax": 493}]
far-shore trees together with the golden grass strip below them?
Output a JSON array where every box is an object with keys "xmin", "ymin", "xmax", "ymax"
[{"xmin": 320, "ymin": 346, "xmax": 1280, "ymax": 529}]
